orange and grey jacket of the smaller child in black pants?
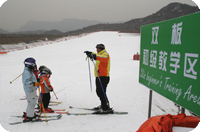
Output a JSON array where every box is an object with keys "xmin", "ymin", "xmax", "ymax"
[{"xmin": 40, "ymin": 74, "xmax": 53, "ymax": 94}]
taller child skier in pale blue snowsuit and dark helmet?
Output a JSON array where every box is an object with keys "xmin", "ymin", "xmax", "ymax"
[{"xmin": 22, "ymin": 57, "xmax": 39, "ymax": 122}]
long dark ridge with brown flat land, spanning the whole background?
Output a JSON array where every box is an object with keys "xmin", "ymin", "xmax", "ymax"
[{"xmin": 0, "ymin": 2, "xmax": 200, "ymax": 44}]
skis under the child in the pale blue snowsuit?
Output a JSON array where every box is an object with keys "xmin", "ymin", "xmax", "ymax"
[{"xmin": 9, "ymin": 114, "xmax": 62, "ymax": 125}]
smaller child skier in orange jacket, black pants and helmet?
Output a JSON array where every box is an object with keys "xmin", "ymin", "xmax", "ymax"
[{"xmin": 39, "ymin": 67, "xmax": 54, "ymax": 113}]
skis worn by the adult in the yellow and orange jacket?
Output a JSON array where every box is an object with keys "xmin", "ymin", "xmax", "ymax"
[{"xmin": 66, "ymin": 106, "xmax": 128, "ymax": 115}]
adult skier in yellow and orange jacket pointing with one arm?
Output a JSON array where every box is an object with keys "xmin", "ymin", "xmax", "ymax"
[{"xmin": 84, "ymin": 44, "xmax": 113, "ymax": 114}]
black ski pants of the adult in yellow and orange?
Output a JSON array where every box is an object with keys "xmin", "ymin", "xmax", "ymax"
[{"xmin": 96, "ymin": 77, "xmax": 110, "ymax": 110}]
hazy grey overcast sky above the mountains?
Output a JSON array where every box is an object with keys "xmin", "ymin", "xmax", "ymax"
[{"xmin": 0, "ymin": 0, "xmax": 197, "ymax": 31}]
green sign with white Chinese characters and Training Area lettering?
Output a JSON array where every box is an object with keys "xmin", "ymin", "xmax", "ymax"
[{"xmin": 139, "ymin": 12, "xmax": 200, "ymax": 116}]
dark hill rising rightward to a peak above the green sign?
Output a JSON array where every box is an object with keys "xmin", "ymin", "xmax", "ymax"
[{"xmin": 65, "ymin": 2, "xmax": 200, "ymax": 35}]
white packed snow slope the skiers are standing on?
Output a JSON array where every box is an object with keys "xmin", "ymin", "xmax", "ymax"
[{"xmin": 0, "ymin": 32, "xmax": 197, "ymax": 132}]
